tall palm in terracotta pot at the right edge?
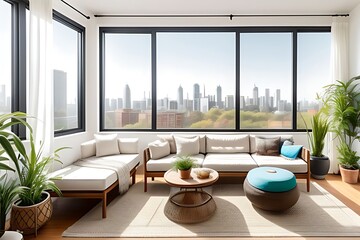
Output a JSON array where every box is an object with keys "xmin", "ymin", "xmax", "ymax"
[{"xmin": 321, "ymin": 76, "xmax": 360, "ymax": 183}]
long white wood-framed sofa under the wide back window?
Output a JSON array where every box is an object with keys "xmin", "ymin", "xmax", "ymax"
[{"xmin": 143, "ymin": 134, "xmax": 310, "ymax": 192}]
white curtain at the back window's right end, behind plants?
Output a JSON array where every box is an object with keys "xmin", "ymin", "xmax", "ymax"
[{"xmin": 329, "ymin": 17, "xmax": 349, "ymax": 174}]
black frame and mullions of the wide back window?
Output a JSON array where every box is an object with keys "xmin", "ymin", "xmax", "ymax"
[{"xmin": 99, "ymin": 27, "xmax": 331, "ymax": 132}]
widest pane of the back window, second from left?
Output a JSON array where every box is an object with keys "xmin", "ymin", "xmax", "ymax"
[{"xmin": 156, "ymin": 32, "xmax": 236, "ymax": 129}]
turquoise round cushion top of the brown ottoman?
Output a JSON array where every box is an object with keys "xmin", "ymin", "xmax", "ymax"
[{"xmin": 246, "ymin": 167, "xmax": 296, "ymax": 192}]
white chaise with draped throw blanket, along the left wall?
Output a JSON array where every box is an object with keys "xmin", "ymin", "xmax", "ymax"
[{"xmin": 50, "ymin": 134, "xmax": 140, "ymax": 218}]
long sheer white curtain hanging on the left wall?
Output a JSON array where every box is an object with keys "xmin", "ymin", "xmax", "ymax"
[{"xmin": 27, "ymin": 0, "xmax": 54, "ymax": 156}]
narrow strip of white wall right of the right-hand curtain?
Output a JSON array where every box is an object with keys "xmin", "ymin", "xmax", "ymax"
[{"xmin": 349, "ymin": 4, "xmax": 360, "ymax": 153}]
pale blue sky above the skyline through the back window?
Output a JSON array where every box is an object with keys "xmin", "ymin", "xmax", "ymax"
[{"xmin": 105, "ymin": 33, "xmax": 330, "ymax": 101}]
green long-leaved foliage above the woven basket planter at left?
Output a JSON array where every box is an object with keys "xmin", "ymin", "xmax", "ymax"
[{"xmin": 0, "ymin": 113, "xmax": 64, "ymax": 206}]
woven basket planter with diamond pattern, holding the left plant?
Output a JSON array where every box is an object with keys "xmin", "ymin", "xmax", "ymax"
[{"xmin": 10, "ymin": 192, "xmax": 53, "ymax": 235}]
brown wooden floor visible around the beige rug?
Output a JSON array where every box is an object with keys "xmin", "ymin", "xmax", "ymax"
[{"xmin": 25, "ymin": 175, "xmax": 360, "ymax": 240}]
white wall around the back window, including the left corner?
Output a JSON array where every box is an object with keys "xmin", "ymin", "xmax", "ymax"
[{"xmin": 50, "ymin": 0, "xmax": 331, "ymax": 168}]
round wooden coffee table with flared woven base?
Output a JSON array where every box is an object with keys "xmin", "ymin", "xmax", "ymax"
[{"xmin": 164, "ymin": 169, "xmax": 219, "ymax": 223}]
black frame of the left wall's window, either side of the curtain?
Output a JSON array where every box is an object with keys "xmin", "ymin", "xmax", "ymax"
[{"xmin": 3, "ymin": 0, "xmax": 85, "ymax": 139}]
